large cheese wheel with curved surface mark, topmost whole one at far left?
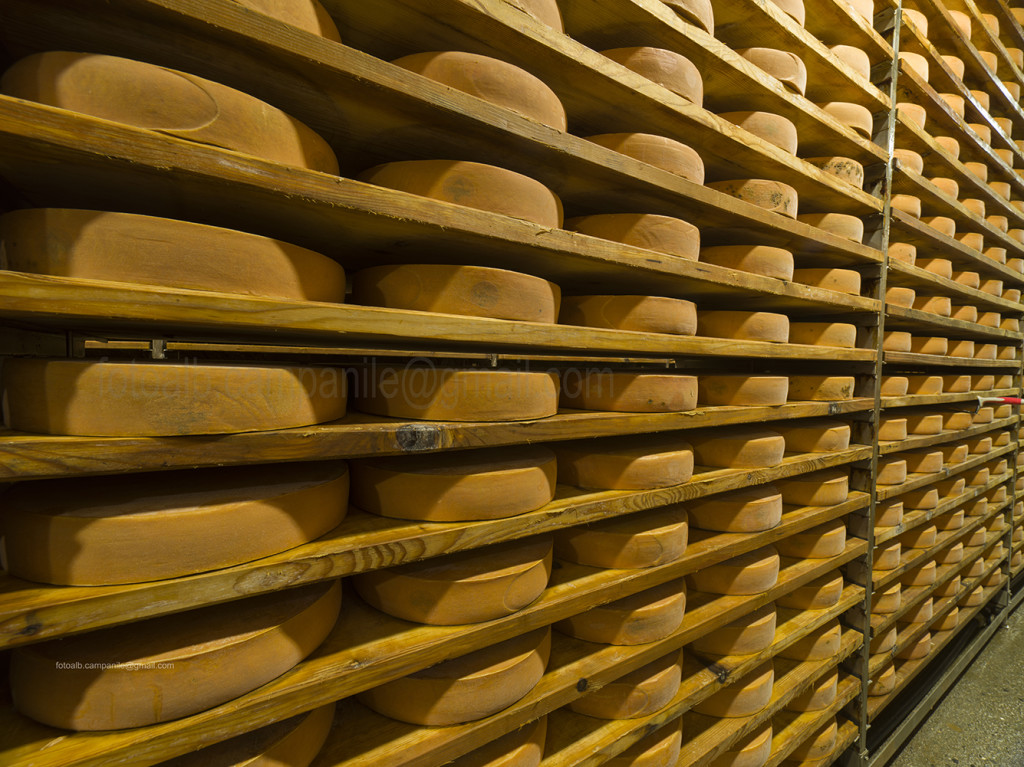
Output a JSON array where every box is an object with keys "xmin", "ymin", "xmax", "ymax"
[{"xmin": 0, "ymin": 51, "xmax": 338, "ymax": 174}]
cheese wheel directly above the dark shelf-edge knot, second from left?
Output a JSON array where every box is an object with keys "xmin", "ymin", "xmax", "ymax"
[{"xmin": 355, "ymin": 365, "xmax": 558, "ymax": 423}]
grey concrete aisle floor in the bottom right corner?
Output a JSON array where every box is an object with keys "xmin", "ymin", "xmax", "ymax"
[{"xmin": 888, "ymin": 608, "xmax": 1024, "ymax": 767}]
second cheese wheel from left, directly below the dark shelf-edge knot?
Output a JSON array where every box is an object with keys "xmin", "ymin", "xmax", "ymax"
[{"xmin": 351, "ymin": 445, "xmax": 556, "ymax": 522}]
